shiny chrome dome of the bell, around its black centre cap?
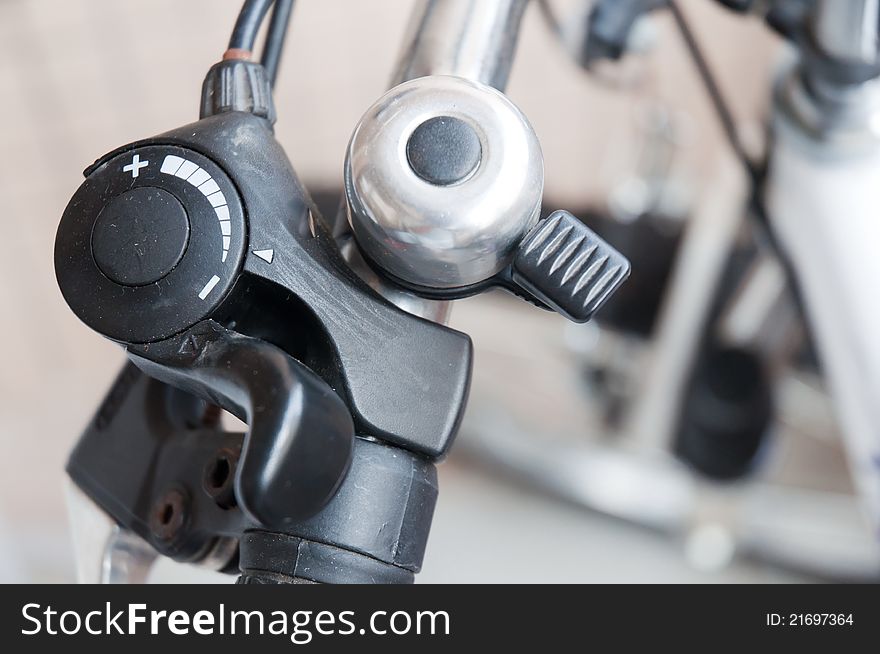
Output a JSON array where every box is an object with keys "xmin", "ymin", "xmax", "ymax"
[{"xmin": 345, "ymin": 75, "xmax": 544, "ymax": 288}]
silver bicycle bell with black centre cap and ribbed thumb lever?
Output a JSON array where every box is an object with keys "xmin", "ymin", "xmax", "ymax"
[{"xmin": 345, "ymin": 75, "xmax": 630, "ymax": 322}]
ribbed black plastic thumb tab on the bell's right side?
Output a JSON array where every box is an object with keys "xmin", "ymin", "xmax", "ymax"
[{"xmin": 512, "ymin": 211, "xmax": 630, "ymax": 322}]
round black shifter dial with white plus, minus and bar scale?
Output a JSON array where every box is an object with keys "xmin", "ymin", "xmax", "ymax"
[{"xmin": 55, "ymin": 145, "xmax": 247, "ymax": 343}]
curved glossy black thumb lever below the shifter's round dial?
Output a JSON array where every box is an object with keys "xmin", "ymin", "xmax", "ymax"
[{"xmin": 128, "ymin": 320, "xmax": 354, "ymax": 529}]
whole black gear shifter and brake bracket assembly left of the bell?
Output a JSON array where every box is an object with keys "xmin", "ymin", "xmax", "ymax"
[{"xmin": 55, "ymin": 52, "xmax": 471, "ymax": 581}]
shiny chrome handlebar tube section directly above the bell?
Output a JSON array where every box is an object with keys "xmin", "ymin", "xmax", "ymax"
[{"xmin": 393, "ymin": 0, "xmax": 527, "ymax": 90}]
